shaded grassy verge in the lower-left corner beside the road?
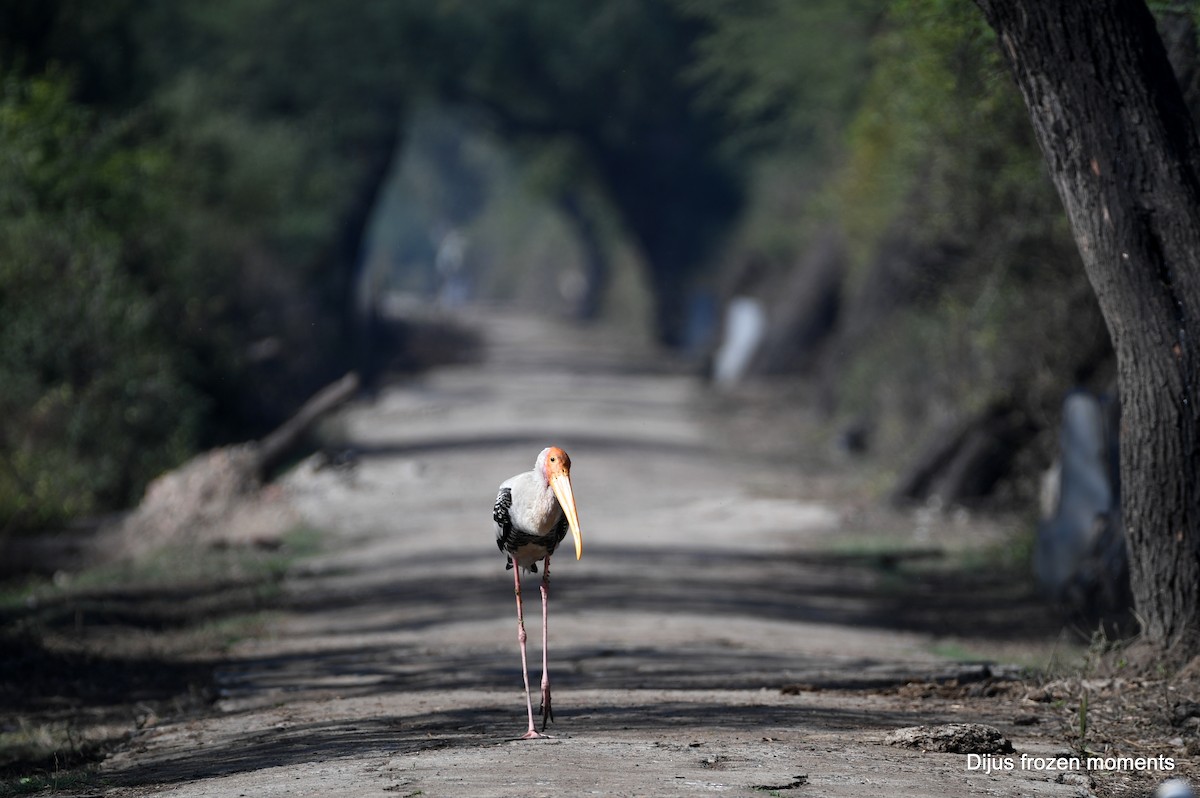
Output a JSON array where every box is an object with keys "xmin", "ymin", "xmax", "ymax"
[{"xmin": 0, "ymin": 527, "xmax": 320, "ymax": 796}]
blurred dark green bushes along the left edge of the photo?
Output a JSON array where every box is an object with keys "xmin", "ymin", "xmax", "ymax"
[{"xmin": 0, "ymin": 31, "xmax": 348, "ymax": 528}]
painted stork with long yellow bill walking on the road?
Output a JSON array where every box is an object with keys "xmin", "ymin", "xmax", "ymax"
[{"xmin": 492, "ymin": 446, "xmax": 583, "ymax": 739}]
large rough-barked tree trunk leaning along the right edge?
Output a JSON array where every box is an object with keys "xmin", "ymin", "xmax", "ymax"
[{"xmin": 977, "ymin": 0, "xmax": 1200, "ymax": 660}]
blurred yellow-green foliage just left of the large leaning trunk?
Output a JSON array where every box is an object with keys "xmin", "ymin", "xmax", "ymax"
[{"xmin": 680, "ymin": 0, "xmax": 1106, "ymax": 501}]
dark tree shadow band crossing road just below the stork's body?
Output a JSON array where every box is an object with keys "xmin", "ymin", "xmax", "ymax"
[{"xmin": 278, "ymin": 546, "xmax": 1063, "ymax": 641}]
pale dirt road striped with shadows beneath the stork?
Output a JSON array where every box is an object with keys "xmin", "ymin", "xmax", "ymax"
[{"xmin": 102, "ymin": 307, "xmax": 1086, "ymax": 798}]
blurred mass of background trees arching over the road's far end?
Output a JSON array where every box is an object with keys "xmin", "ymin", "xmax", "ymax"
[{"xmin": 0, "ymin": 0, "xmax": 1190, "ymax": 537}]
